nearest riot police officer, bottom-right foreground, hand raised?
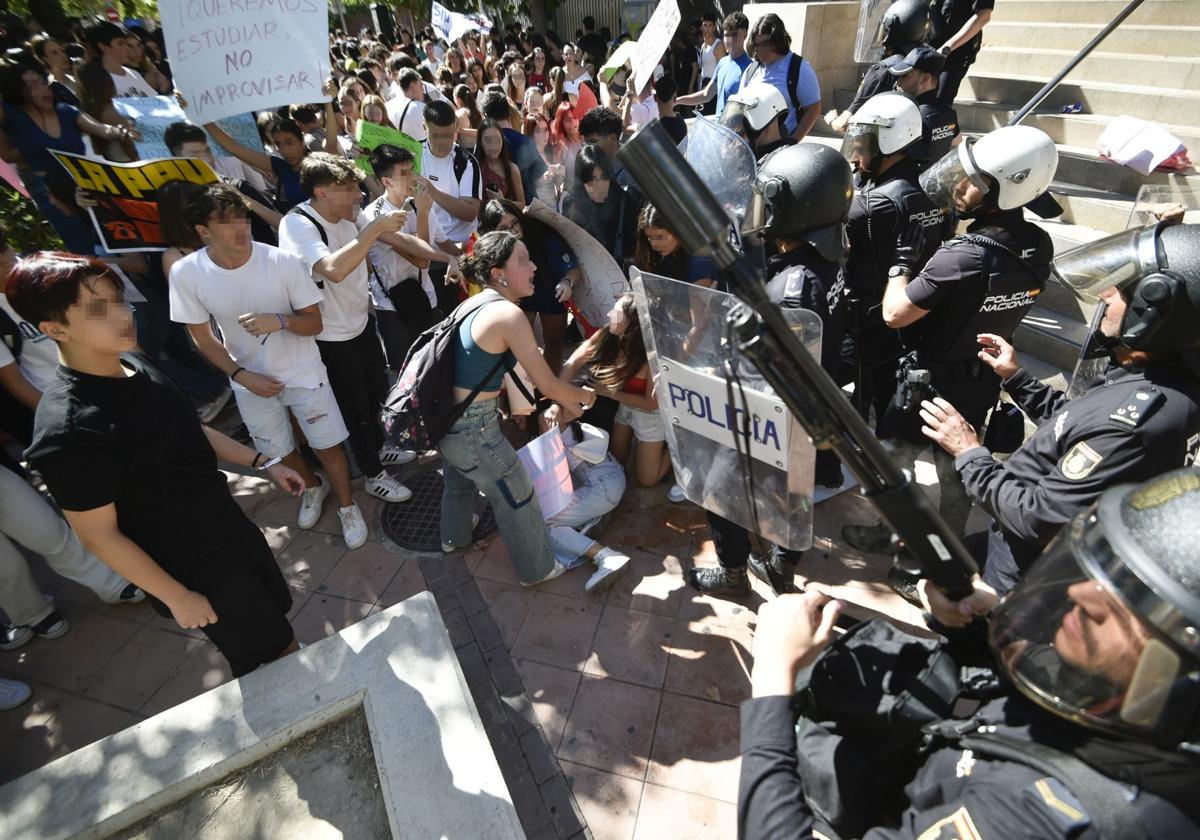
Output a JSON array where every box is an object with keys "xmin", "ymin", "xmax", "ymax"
[{"xmin": 738, "ymin": 469, "xmax": 1200, "ymax": 840}]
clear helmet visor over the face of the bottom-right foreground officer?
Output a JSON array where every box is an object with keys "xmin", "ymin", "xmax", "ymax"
[{"xmin": 990, "ymin": 514, "xmax": 1200, "ymax": 740}]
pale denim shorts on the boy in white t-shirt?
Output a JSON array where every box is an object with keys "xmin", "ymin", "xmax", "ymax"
[{"xmin": 233, "ymin": 383, "xmax": 350, "ymax": 458}]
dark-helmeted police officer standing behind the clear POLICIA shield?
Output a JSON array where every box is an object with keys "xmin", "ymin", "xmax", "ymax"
[{"xmin": 688, "ymin": 144, "xmax": 852, "ymax": 596}]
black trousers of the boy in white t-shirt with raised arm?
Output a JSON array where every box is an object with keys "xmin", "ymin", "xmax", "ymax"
[{"xmin": 317, "ymin": 314, "xmax": 388, "ymax": 478}]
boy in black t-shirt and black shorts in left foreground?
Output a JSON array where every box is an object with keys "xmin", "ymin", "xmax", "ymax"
[{"xmin": 8, "ymin": 250, "xmax": 304, "ymax": 677}]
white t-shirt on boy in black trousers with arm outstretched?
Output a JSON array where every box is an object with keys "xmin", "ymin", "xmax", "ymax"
[{"xmin": 280, "ymin": 202, "xmax": 371, "ymax": 341}]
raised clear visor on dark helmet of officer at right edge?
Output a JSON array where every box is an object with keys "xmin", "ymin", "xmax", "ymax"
[{"xmin": 1054, "ymin": 224, "xmax": 1159, "ymax": 300}]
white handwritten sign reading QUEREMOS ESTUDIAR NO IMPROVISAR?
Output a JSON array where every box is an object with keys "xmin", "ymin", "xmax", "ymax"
[{"xmin": 158, "ymin": 0, "xmax": 330, "ymax": 124}]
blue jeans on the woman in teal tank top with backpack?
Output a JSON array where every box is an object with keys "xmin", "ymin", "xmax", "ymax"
[{"xmin": 438, "ymin": 398, "xmax": 554, "ymax": 584}]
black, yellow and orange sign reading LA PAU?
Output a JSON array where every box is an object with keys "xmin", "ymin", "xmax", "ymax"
[{"xmin": 50, "ymin": 150, "xmax": 217, "ymax": 253}]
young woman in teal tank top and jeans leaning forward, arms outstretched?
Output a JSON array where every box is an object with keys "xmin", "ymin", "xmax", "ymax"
[{"xmin": 438, "ymin": 230, "xmax": 596, "ymax": 586}]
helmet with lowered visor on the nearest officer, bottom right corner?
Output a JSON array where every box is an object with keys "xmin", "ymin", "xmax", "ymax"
[{"xmin": 989, "ymin": 470, "xmax": 1200, "ymax": 750}]
